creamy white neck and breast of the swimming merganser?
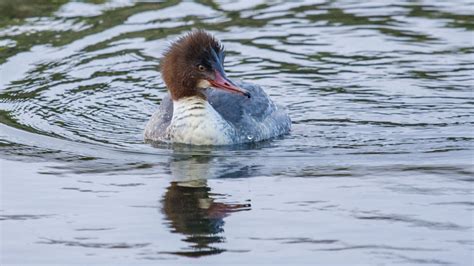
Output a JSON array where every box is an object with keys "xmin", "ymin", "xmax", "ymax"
[{"xmin": 168, "ymin": 96, "xmax": 234, "ymax": 145}]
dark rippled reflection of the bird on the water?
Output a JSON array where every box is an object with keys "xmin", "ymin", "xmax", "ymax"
[{"xmin": 162, "ymin": 156, "xmax": 250, "ymax": 257}]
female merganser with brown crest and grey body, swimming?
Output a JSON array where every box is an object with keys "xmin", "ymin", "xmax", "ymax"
[{"xmin": 144, "ymin": 30, "xmax": 291, "ymax": 145}]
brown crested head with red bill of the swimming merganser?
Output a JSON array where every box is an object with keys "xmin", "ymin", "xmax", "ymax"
[{"xmin": 161, "ymin": 30, "xmax": 250, "ymax": 100}]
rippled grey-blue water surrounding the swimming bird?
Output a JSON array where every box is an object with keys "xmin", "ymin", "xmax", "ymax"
[{"xmin": 0, "ymin": 0, "xmax": 474, "ymax": 265}]
